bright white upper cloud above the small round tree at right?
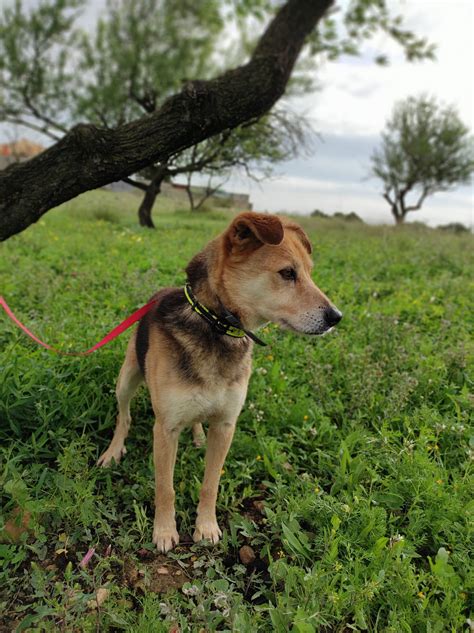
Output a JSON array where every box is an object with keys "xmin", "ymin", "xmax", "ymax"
[{"xmin": 304, "ymin": 0, "xmax": 474, "ymax": 135}]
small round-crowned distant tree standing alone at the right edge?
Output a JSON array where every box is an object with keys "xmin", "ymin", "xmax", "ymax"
[{"xmin": 371, "ymin": 96, "xmax": 474, "ymax": 224}]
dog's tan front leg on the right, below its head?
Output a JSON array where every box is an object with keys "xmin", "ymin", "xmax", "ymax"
[{"xmin": 193, "ymin": 420, "xmax": 236, "ymax": 543}]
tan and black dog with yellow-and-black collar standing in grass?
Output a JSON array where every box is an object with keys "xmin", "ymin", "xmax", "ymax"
[{"xmin": 98, "ymin": 212, "xmax": 342, "ymax": 553}]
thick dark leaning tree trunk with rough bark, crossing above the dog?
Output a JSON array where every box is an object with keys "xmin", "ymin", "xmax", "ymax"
[{"xmin": 0, "ymin": 0, "xmax": 334, "ymax": 240}]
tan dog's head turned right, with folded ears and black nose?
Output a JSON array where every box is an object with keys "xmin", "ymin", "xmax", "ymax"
[{"xmin": 215, "ymin": 212, "xmax": 342, "ymax": 334}]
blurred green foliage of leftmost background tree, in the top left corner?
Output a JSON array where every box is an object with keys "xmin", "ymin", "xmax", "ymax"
[{"xmin": 0, "ymin": 0, "xmax": 85, "ymax": 139}]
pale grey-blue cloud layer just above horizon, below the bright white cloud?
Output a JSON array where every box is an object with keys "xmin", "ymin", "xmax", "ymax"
[{"xmin": 190, "ymin": 126, "xmax": 473, "ymax": 226}]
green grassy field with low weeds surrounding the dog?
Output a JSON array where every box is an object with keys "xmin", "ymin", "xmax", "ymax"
[{"xmin": 0, "ymin": 192, "xmax": 474, "ymax": 633}]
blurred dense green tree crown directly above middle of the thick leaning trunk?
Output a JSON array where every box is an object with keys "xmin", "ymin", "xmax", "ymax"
[{"xmin": 74, "ymin": 0, "xmax": 224, "ymax": 128}]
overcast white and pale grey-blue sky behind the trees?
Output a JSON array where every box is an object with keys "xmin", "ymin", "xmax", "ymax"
[{"xmin": 0, "ymin": 0, "xmax": 474, "ymax": 228}]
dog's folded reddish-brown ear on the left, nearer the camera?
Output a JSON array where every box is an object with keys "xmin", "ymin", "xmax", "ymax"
[{"xmin": 225, "ymin": 211, "xmax": 283, "ymax": 252}]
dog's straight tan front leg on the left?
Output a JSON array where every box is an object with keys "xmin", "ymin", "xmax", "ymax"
[{"xmin": 153, "ymin": 420, "xmax": 179, "ymax": 552}]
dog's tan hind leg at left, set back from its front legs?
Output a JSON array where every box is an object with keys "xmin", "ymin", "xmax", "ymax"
[{"xmin": 97, "ymin": 336, "xmax": 143, "ymax": 467}]
